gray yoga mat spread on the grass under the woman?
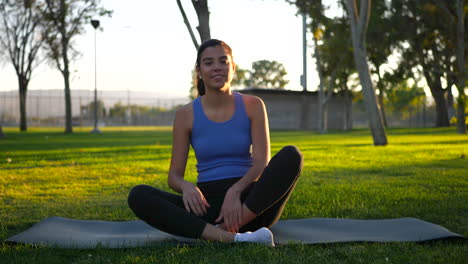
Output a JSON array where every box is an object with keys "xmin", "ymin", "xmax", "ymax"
[{"xmin": 6, "ymin": 217, "xmax": 463, "ymax": 248}]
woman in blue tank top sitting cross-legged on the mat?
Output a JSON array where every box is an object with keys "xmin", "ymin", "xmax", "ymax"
[{"xmin": 128, "ymin": 39, "xmax": 302, "ymax": 246}]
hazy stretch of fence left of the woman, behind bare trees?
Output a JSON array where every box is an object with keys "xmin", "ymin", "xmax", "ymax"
[{"xmin": 0, "ymin": 90, "xmax": 189, "ymax": 126}]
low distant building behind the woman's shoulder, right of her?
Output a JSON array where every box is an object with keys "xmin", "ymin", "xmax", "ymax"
[{"xmin": 238, "ymin": 88, "xmax": 353, "ymax": 130}]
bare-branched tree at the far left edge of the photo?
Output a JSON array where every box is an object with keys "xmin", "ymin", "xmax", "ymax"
[{"xmin": 0, "ymin": 0, "xmax": 43, "ymax": 131}]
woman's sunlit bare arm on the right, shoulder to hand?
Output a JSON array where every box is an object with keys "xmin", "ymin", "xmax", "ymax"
[{"xmin": 216, "ymin": 95, "xmax": 270, "ymax": 232}]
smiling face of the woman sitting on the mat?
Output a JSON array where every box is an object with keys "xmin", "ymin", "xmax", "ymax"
[{"xmin": 198, "ymin": 46, "xmax": 235, "ymax": 93}]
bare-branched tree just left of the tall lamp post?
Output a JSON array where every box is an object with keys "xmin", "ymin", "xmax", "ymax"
[{"xmin": 43, "ymin": 0, "xmax": 112, "ymax": 133}]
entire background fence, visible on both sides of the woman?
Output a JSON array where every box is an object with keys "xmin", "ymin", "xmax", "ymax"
[{"xmin": 0, "ymin": 90, "xmax": 435, "ymax": 128}]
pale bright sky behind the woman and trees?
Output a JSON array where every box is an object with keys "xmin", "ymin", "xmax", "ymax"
[{"xmin": 0, "ymin": 0, "xmax": 318, "ymax": 97}]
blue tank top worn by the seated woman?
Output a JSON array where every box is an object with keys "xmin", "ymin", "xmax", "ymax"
[{"xmin": 191, "ymin": 92, "xmax": 252, "ymax": 182}]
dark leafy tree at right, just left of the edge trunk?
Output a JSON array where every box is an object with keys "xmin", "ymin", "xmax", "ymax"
[{"xmin": 391, "ymin": 0, "xmax": 462, "ymax": 127}]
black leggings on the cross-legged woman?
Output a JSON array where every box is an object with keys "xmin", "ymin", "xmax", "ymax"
[{"xmin": 128, "ymin": 146, "xmax": 302, "ymax": 238}]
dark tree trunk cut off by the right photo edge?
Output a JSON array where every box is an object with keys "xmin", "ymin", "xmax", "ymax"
[{"xmin": 457, "ymin": 0, "xmax": 466, "ymax": 134}]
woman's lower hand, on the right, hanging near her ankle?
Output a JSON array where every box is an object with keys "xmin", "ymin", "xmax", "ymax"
[{"xmin": 215, "ymin": 188, "xmax": 242, "ymax": 233}]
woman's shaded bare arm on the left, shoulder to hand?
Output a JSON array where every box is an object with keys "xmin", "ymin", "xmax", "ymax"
[{"xmin": 168, "ymin": 104, "xmax": 210, "ymax": 215}]
